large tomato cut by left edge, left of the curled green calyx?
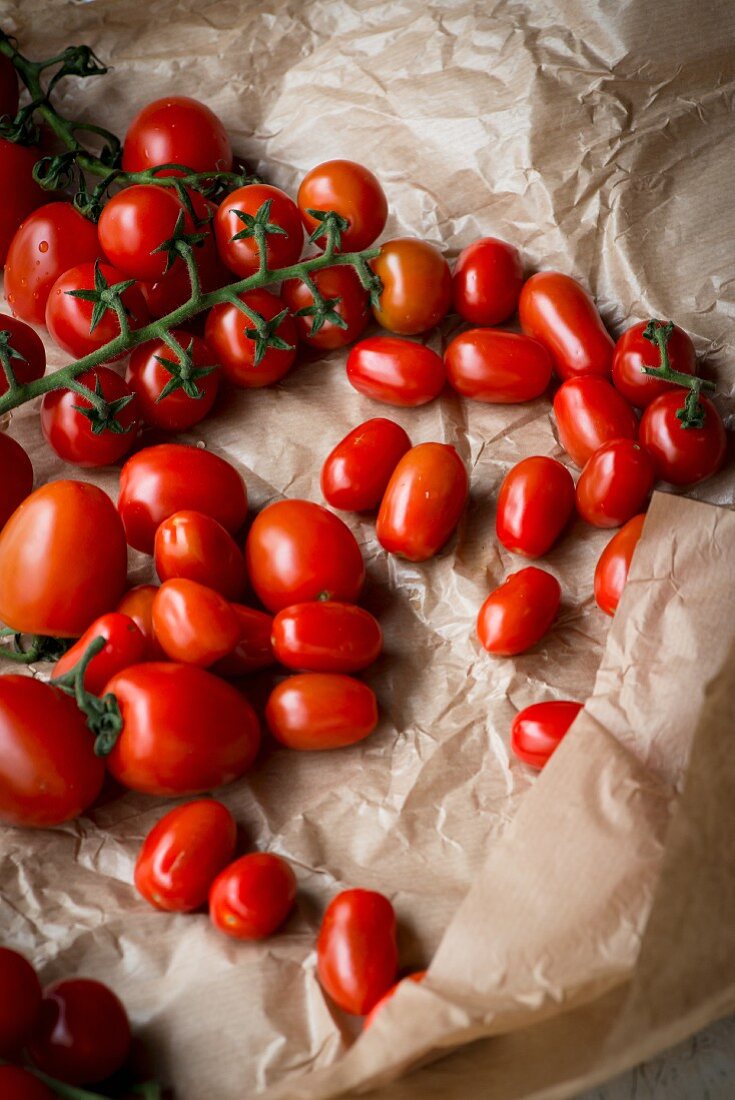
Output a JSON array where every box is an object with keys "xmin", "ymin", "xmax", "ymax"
[{"xmin": 0, "ymin": 675, "xmax": 105, "ymax": 828}]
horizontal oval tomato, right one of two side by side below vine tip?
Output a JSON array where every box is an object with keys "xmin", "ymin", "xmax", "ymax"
[{"xmin": 445, "ymin": 329, "xmax": 551, "ymax": 405}]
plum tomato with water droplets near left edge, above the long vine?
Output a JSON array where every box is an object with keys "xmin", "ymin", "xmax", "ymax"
[{"xmin": 6, "ymin": 202, "xmax": 102, "ymax": 325}]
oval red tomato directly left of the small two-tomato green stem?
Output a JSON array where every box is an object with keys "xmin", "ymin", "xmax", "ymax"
[{"xmin": 553, "ymin": 376, "xmax": 638, "ymax": 468}]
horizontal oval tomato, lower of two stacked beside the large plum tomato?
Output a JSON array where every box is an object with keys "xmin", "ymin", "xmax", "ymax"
[{"xmin": 265, "ymin": 672, "xmax": 377, "ymax": 750}]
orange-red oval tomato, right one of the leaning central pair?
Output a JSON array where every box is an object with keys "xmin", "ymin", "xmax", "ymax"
[{"xmin": 375, "ymin": 443, "xmax": 470, "ymax": 561}]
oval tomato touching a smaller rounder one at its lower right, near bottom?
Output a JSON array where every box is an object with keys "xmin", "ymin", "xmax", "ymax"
[{"xmin": 134, "ymin": 799, "xmax": 238, "ymax": 913}]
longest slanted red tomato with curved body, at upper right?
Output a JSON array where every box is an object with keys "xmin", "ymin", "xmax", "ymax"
[{"xmin": 518, "ymin": 272, "xmax": 615, "ymax": 381}]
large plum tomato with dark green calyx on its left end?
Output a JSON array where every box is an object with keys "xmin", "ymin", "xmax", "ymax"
[{"xmin": 105, "ymin": 661, "xmax": 261, "ymax": 798}]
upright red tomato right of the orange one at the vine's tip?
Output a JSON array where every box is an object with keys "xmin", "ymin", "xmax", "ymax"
[{"xmin": 452, "ymin": 237, "xmax": 523, "ymax": 325}]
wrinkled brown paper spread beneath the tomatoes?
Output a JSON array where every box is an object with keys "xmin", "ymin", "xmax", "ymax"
[{"xmin": 0, "ymin": 0, "xmax": 735, "ymax": 1100}]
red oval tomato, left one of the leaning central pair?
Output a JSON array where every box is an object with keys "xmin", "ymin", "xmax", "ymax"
[{"xmin": 321, "ymin": 417, "xmax": 410, "ymax": 512}]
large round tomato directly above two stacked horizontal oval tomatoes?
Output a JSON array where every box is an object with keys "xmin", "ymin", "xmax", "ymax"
[{"xmin": 245, "ymin": 501, "xmax": 365, "ymax": 612}]
